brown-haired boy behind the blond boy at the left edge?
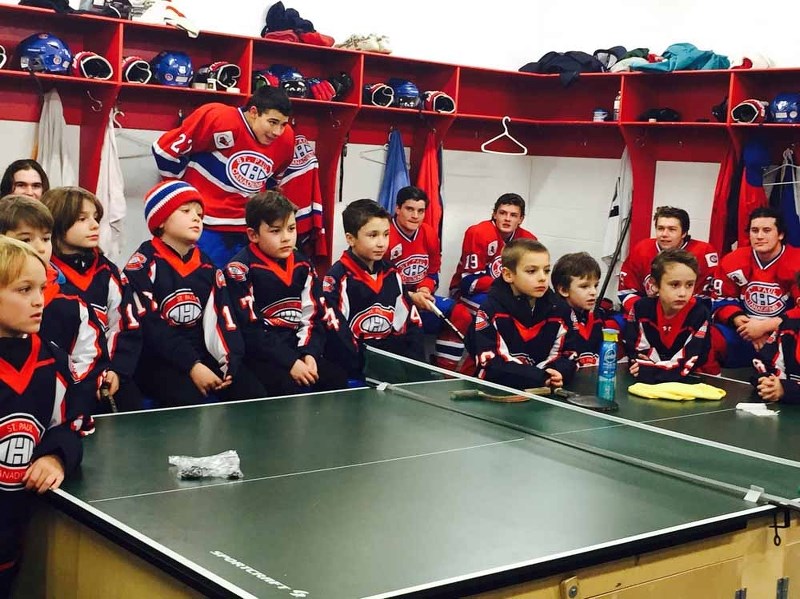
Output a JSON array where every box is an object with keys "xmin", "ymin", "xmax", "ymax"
[{"xmin": 0, "ymin": 195, "xmax": 109, "ymax": 424}]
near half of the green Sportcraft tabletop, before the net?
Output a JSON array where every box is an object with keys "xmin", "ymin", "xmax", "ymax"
[{"xmin": 54, "ymin": 377, "xmax": 780, "ymax": 599}]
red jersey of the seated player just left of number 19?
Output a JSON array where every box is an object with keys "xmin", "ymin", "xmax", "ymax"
[{"xmin": 389, "ymin": 218, "xmax": 442, "ymax": 292}]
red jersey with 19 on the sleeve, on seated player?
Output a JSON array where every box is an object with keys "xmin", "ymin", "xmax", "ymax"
[{"xmin": 450, "ymin": 220, "xmax": 536, "ymax": 295}]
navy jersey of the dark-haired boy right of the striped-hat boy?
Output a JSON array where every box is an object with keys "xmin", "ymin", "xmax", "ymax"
[{"xmin": 225, "ymin": 243, "xmax": 326, "ymax": 370}]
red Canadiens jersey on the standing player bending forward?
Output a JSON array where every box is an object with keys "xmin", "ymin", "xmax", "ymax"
[{"xmin": 153, "ymin": 103, "xmax": 294, "ymax": 233}]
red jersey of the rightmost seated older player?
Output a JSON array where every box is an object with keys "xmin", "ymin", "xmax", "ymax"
[{"xmin": 714, "ymin": 245, "xmax": 800, "ymax": 324}]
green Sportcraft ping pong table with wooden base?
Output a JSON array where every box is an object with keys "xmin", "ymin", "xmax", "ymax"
[{"xmin": 14, "ymin": 351, "xmax": 800, "ymax": 599}]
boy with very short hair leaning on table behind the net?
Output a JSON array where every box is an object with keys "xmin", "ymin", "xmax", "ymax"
[{"xmin": 467, "ymin": 239, "xmax": 576, "ymax": 389}]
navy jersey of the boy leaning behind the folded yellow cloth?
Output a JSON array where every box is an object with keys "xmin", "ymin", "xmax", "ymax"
[{"xmin": 624, "ymin": 297, "xmax": 711, "ymax": 383}]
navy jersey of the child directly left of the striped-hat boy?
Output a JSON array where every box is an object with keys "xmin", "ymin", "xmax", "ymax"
[{"xmin": 52, "ymin": 250, "xmax": 142, "ymax": 376}]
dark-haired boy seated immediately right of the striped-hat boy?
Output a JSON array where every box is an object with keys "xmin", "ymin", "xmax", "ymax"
[{"xmin": 225, "ymin": 191, "xmax": 347, "ymax": 395}]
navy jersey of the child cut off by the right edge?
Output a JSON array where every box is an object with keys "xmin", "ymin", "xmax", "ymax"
[{"xmin": 756, "ymin": 309, "xmax": 800, "ymax": 403}]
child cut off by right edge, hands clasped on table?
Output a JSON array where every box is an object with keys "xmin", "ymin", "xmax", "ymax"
[{"xmin": 753, "ymin": 273, "xmax": 800, "ymax": 404}]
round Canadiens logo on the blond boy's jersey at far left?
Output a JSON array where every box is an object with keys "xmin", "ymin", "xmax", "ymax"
[{"xmin": 0, "ymin": 414, "xmax": 44, "ymax": 491}]
